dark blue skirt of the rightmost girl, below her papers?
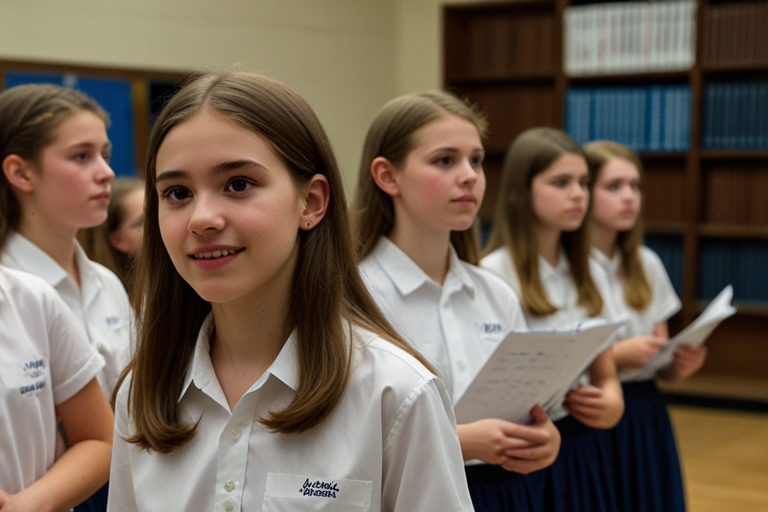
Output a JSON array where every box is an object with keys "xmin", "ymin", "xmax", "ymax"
[{"xmin": 613, "ymin": 380, "xmax": 685, "ymax": 512}]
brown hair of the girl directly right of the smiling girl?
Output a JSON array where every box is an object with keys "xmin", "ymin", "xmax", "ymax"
[{"xmin": 352, "ymin": 91, "xmax": 487, "ymax": 265}]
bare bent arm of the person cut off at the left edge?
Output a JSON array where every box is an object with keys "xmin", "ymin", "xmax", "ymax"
[{"xmin": 0, "ymin": 379, "xmax": 114, "ymax": 512}]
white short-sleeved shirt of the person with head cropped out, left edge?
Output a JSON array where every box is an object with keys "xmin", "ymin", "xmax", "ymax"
[{"xmin": 0, "ymin": 266, "xmax": 104, "ymax": 494}]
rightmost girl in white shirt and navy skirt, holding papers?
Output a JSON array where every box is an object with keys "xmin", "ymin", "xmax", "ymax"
[{"xmin": 584, "ymin": 141, "xmax": 706, "ymax": 512}]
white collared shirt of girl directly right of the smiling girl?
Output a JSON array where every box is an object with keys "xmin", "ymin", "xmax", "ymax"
[{"xmin": 360, "ymin": 237, "xmax": 526, "ymax": 403}]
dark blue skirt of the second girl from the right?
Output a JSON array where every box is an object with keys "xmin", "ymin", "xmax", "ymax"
[{"xmin": 542, "ymin": 416, "xmax": 620, "ymax": 512}]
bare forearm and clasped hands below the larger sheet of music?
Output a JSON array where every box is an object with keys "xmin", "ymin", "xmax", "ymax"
[{"xmin": 458, "ymin": 405, "xmax": 560, "ymax": 474}]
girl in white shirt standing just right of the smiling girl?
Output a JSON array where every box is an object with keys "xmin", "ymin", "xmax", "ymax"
[{"xmin": 352, "ymin": 92, "xmax": 560, "ymax": 511}]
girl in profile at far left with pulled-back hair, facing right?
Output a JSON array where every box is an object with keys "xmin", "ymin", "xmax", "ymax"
[{"xmin": 0, "ymin": 84, "xmax": 132, "ymax": 511}]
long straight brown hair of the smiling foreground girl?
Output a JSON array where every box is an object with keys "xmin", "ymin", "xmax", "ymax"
[{"xmin": 116, "ymin": 72, "xmax": 431, "ymax": 453}]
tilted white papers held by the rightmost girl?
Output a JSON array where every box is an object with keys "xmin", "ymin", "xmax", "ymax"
[{"xmin": 619, "ymin": 285, "xmax": 736, "ymax": 380}]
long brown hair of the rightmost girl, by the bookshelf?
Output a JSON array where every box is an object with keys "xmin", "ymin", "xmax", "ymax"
[{"xmin": 584, "ymin": 140, "xmax": 653, "ymax": 311}]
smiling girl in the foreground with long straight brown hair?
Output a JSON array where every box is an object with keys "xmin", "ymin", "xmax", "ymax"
[{"xmin": 109, "ymin": 72, "xmax": 471, "ymax": 511}]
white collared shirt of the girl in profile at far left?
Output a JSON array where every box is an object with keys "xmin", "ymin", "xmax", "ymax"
[{"xmin": 2, "ymin": 233, "xmax": 133, "ymax": 399}]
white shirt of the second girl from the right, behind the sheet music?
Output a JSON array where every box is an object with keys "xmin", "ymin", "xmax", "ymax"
[{"xmin": 480, "ymin": 247, "xmax": 619, "ymax": 421}]
